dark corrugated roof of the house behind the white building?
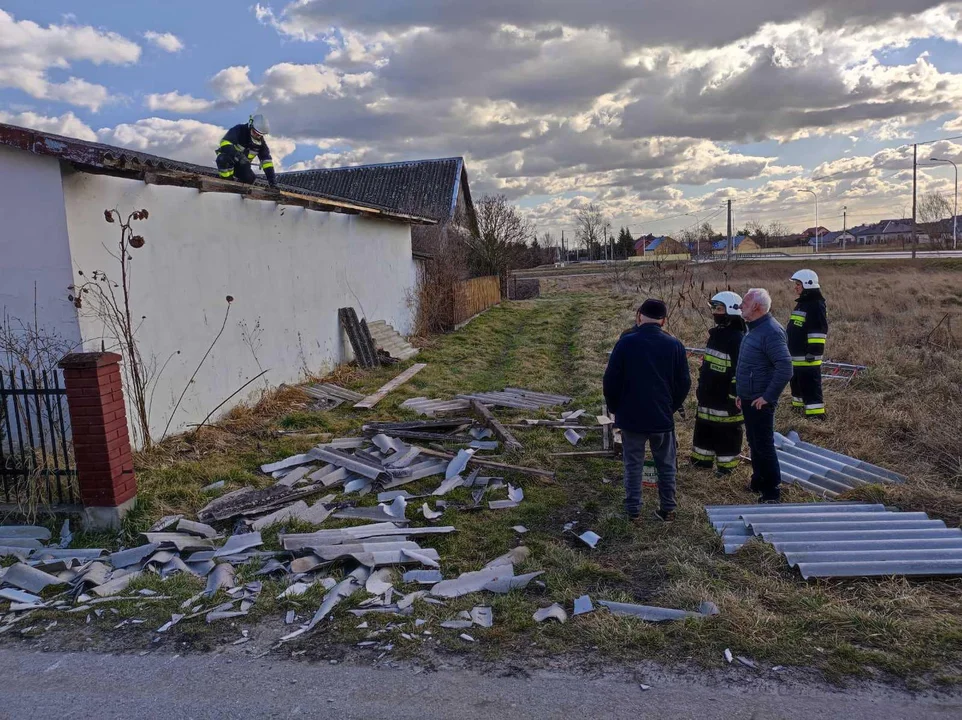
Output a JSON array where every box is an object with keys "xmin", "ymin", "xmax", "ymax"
[{"xmin": 278, "ymin": 157, "xmax": 470, "ymax": 223}]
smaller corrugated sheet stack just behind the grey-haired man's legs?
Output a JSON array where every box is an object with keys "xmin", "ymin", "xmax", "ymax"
[{"xmin": 775, "ymin": 431, "xmax": 906, "ymax": 498}]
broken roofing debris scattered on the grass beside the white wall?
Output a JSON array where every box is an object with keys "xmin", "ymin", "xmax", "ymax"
[{"xmin": 0, "ymin": 388, "xmax": 608, "ymax": 650}]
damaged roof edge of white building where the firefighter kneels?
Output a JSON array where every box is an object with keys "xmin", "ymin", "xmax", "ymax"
[{"xmin": 0, "ymin": 123, "xmax": 437, "ymax": 224}]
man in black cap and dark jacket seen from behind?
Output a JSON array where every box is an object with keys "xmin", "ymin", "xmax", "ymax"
[{"xmin": 604, "ymin": 299, "xmax": 691, "ymax": 521}]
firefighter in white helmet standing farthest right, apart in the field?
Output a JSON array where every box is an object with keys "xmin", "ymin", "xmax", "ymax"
[{"xmin": 785, "ymin": 270, "xmax": 828, "ymax": 420}]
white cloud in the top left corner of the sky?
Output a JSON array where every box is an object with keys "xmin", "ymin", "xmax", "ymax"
[{"xmin": 0, "ymin": 10, "xmax": 140, "ymax": 112}]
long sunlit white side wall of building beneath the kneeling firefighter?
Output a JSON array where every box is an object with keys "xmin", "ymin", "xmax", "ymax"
[{"xmin": 63, "ymin": 173, "xmax": 414, "ymax": 440}]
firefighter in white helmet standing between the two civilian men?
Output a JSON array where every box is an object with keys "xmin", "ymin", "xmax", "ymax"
[{"xmin": 691, "ymin": 292, "xmax": 745, "ymax": 473}]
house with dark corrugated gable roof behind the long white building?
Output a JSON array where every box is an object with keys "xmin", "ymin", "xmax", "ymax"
[{"xmin": 277, "ymin": 157, "xmax": 480, "ymax": 257}]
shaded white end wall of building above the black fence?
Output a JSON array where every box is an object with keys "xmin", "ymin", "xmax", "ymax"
[{"xmin": 0, "ymin": 147, "xmax": 80, "ymax": 348}]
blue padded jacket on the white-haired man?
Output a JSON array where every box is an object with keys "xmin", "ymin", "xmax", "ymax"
[{"xmin": 735, "ymin": 314, "xmax": 792, "ymax": 405}]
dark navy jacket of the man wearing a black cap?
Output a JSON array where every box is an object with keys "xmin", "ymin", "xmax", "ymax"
[{"xmin": 604, "ymin": 324, "xmax": 691, "ymax": 433}]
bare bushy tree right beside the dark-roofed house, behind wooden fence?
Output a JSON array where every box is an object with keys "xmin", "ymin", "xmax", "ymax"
[{"xmin": 467, "ymin": 195, "xmax": 532, "ymax": 286}]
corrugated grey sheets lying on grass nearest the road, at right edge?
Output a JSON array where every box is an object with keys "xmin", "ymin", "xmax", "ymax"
[{"xmin": 705, "ymin": 503, "xmax": 962, "ymax": 580}]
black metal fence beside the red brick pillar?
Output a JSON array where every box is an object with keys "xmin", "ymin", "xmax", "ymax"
[{"xmin": 0, "ymin": 369, "xmax": 79, "ymax": 506}]
